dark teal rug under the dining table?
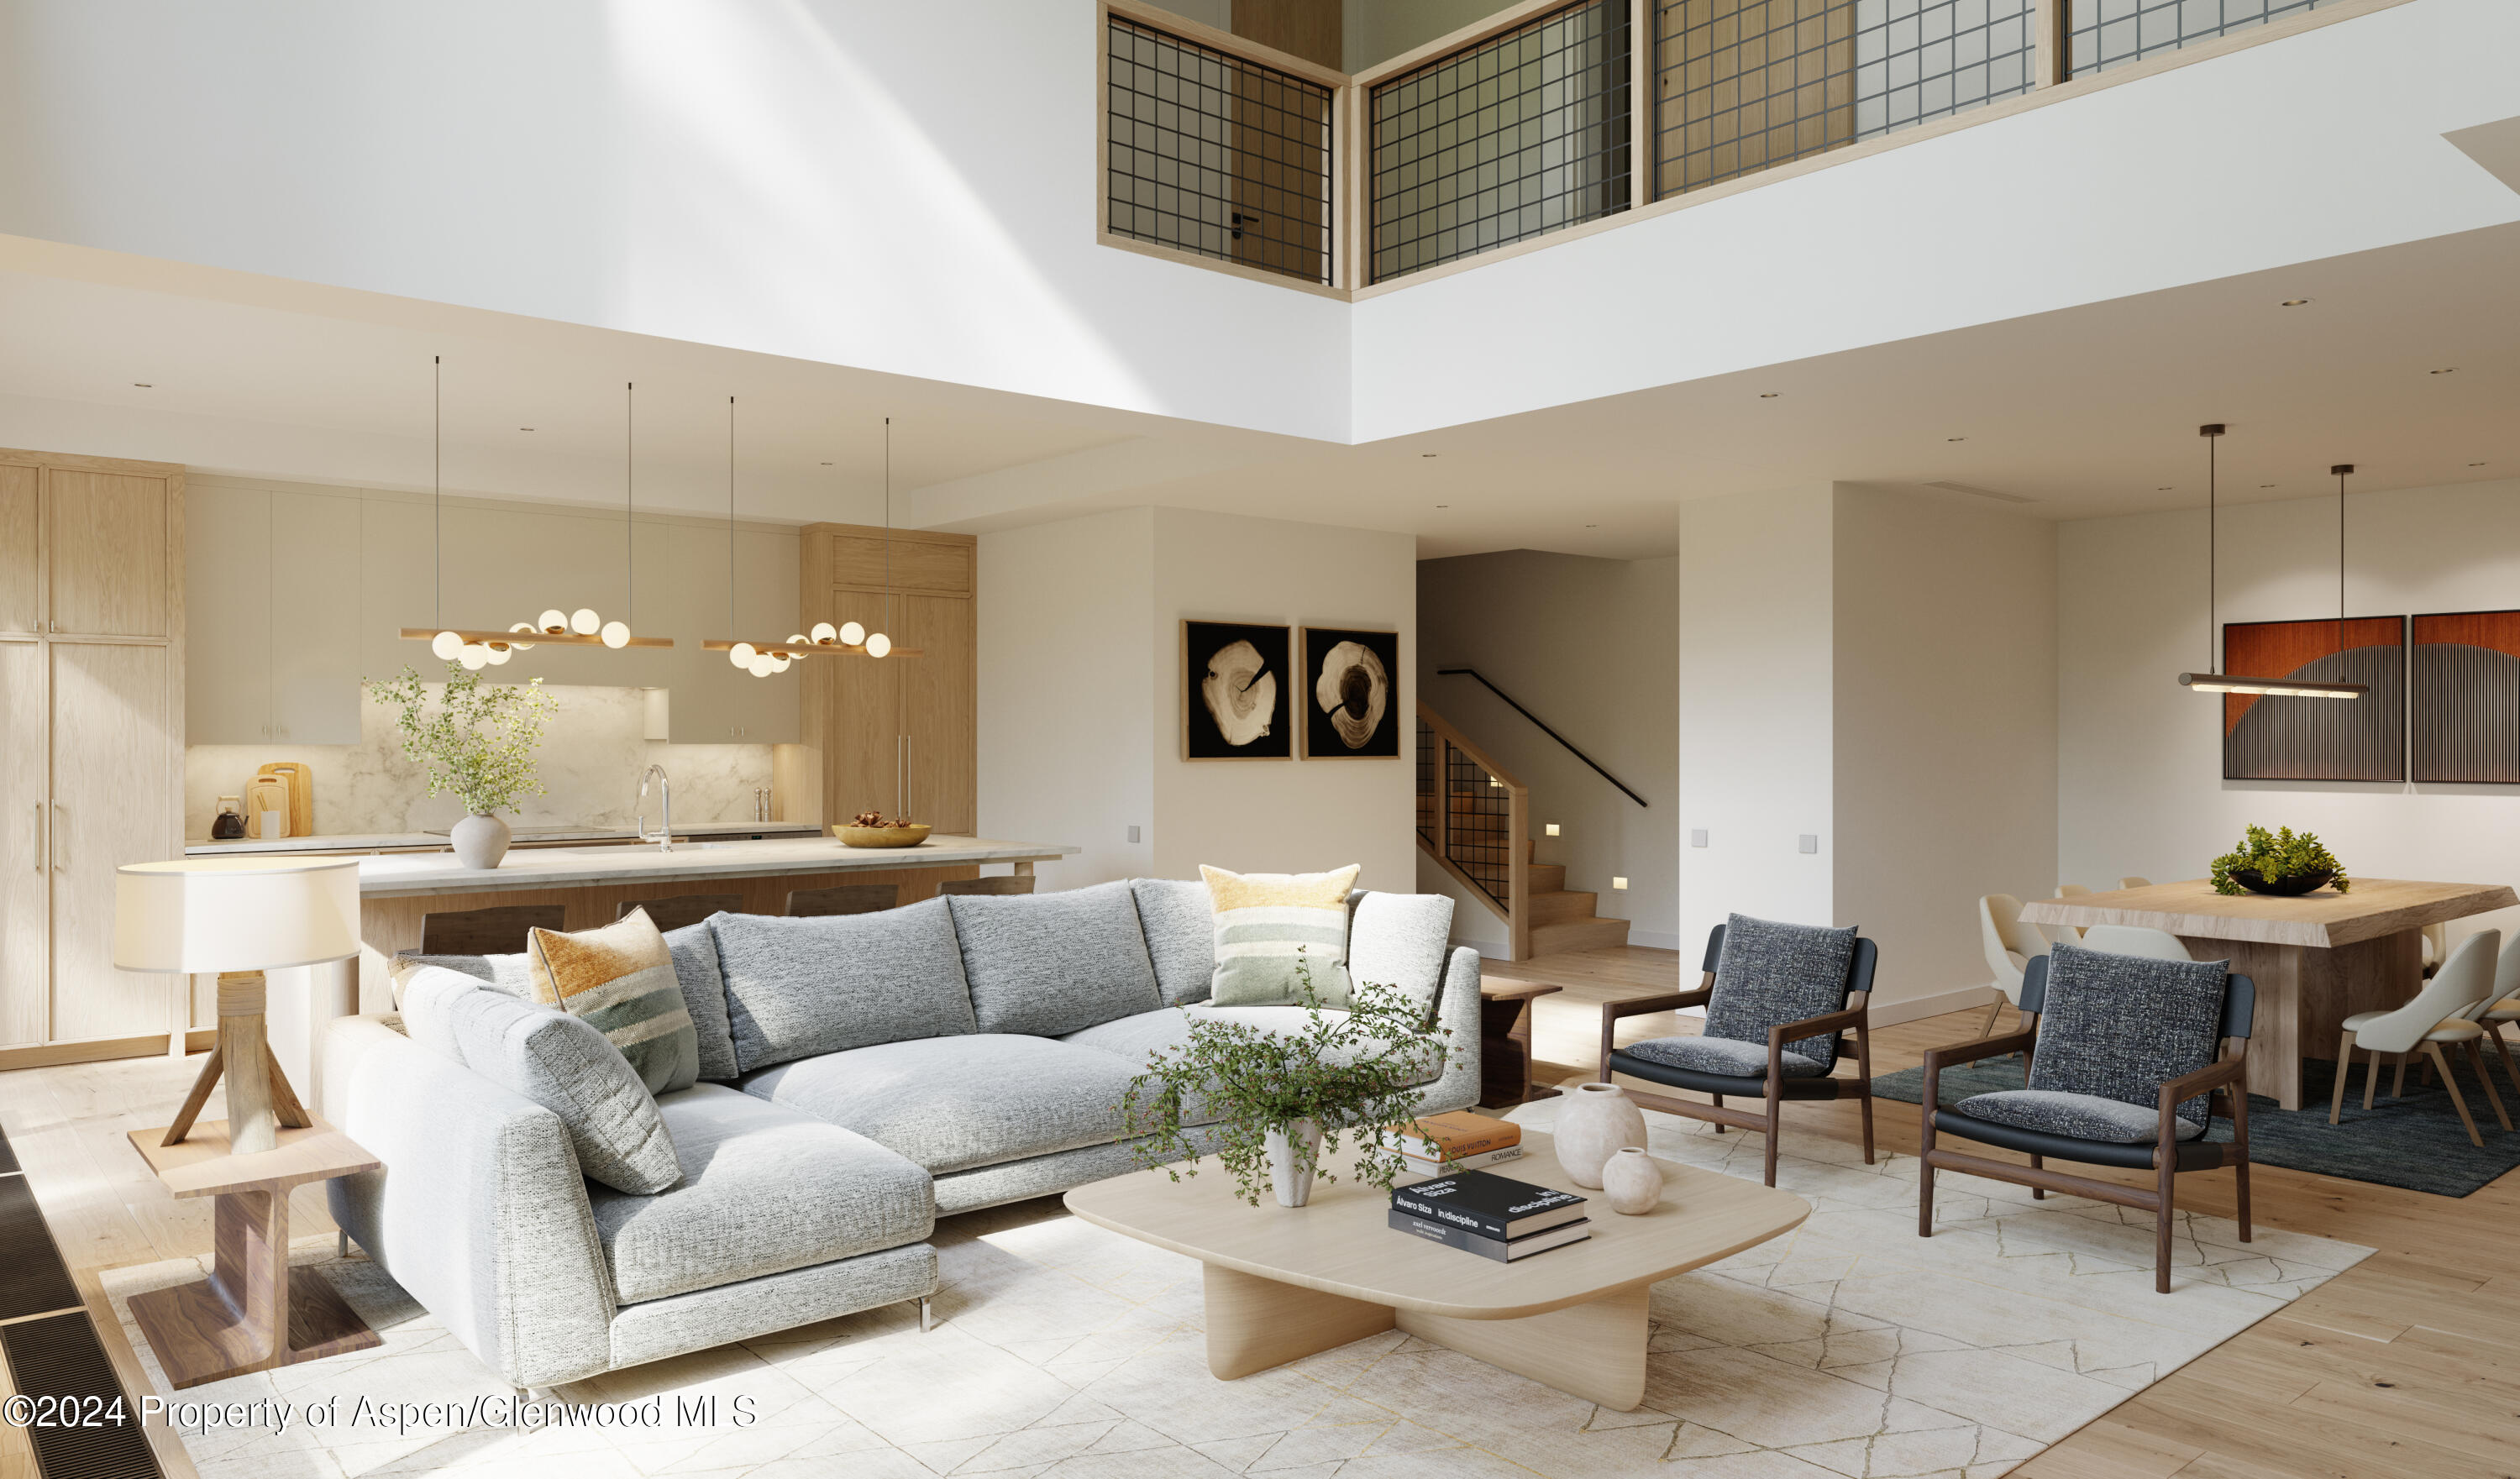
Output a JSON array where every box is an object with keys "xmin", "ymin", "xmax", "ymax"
[{"xmin": 1872, "ymin": 1058, "xmax": 2520, "ymax": 1197}]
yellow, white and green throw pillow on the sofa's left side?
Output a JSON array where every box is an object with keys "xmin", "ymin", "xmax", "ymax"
[{"xmin": 524, "ymin": 910, "xmax": 701, "ymax": 1094}]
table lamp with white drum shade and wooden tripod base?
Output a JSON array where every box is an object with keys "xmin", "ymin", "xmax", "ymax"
[{"xmin": 113, "ymin": 857, "xmax": 358, "ymax": 1156}]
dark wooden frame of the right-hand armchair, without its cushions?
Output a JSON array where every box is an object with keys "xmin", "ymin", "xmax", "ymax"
[{"xmin": 1915, "ymin": 955, "xmax": 2258, "ymax": 1295}]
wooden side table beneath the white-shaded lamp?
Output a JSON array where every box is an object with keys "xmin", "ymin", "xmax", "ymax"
[{"xmin": 131, "ymin": 1119, "xmax": 383, "ymax": 1388}]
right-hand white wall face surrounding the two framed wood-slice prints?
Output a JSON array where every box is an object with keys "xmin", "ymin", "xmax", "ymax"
[{"xmin": 1147, "ymin": 509, "xmax": 1416, "ymax": 892}]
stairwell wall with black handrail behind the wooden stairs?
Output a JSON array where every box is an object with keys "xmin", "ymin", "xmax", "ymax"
[{"xmin": 1419, "ymin": 549, "xmax": 1681, "ymax": 950}]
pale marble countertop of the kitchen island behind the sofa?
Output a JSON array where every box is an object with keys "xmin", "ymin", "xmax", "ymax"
[{"xmin": 358, "ymin": 837, "xmax": 1084, "ymax": 899}]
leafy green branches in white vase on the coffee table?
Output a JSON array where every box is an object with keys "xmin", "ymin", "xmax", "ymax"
[{"xmin": 1119, "ymin": 955, "xmax": 1449, "ymax": 1207}]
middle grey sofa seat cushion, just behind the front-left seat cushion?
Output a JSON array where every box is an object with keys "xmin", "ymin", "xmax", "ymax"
[{"xmin": 743, "ymin": 1033, "xmax": 1137, "ymax": 1174}]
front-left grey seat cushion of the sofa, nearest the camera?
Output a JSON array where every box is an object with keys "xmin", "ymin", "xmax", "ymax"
[{"xmin": 587, "ymin": 1083, "xmax": 935, "ymax": 1305}]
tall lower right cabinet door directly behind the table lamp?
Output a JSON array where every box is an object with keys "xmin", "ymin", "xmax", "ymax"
[{"xmin": 48, "ymin": 642, "xmax": 181, "ymax": 1041}]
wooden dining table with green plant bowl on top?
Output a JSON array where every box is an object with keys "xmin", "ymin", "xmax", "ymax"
[{"xmin": 2021, "ymin": 879, "xmax": 2520, "ymax": 1109}]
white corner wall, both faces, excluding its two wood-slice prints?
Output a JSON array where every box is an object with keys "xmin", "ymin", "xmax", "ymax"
[{"xmin": 980, "ymin": 509, "xmax": 1416, "ymax": 889}]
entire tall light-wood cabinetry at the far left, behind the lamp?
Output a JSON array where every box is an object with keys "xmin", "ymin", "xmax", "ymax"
[{"xmin": 0, "ymin": 448, "xmax": 189, "ymax": 1068}]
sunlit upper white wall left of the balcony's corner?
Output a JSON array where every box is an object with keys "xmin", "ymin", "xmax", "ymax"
[{"xmin": 0, "ymin": 0, "xmax": 1348, "ymax": 438}]
